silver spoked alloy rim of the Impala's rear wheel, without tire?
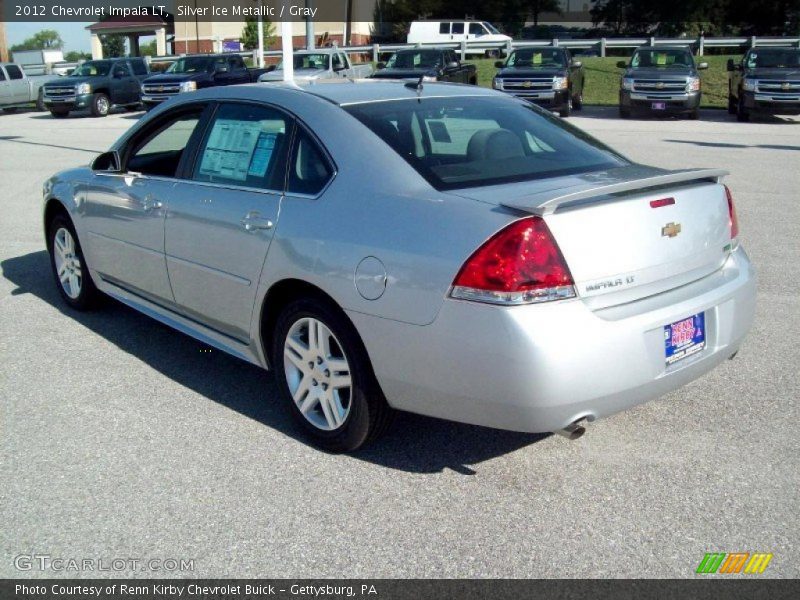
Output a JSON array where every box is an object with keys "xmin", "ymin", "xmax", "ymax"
[{"xmin": 283, "ymin": 317, "xmax": 353, "ymax": 431}]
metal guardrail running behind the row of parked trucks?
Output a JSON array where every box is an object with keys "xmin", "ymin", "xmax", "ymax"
[{"xmin": 25, "ymin": 35, "xmax": 800, "ymax": 75}]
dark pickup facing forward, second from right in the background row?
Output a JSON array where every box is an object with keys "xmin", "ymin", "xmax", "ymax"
[{"xmin": 617, "ymin": 46, "xmax": 708, "ymax": 119}]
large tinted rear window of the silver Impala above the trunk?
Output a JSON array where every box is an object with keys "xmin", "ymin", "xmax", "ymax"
[{"xmin": 345, "ymin": 95, "xmax": 629, "ymax": 190}]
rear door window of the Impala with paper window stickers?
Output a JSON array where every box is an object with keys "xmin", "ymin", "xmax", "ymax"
[{"xmin": 192, "ymin": 104, "xmax": 290, "ymax": 190}]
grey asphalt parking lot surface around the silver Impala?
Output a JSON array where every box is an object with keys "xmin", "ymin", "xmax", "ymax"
[{"xmin": 0, "ymin": 107, "xmax": 800, "ymax": 578}]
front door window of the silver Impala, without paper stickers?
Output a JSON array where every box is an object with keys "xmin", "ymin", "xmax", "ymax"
[{"xmin": 127, "ymin": 107, "xmax": 203, "ymax": 177}]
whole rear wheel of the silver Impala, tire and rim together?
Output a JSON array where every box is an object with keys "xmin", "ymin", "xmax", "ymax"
[{"xmin": 272, "ymin": 297, "xmax": 393, "ymax": 452}]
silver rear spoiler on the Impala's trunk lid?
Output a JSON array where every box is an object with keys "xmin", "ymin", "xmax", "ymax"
[{"xmin": 500, "ymin": 169, "xmax": 728, "ymax": 215}]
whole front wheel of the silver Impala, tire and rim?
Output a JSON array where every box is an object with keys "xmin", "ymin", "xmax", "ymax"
[{"xmin": 47, "ymin": 214, "xmax": 102, "ymax": 311}]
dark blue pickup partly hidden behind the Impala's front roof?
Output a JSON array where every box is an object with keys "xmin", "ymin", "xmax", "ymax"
[{"xmin": 142, "ymin": 54, "xmax": 267, "ymax": 110}]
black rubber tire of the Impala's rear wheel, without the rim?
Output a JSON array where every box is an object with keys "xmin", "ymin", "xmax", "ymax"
[{"xmin": 271, "ymin": 298, "xmax": 384, "ymax": 452}]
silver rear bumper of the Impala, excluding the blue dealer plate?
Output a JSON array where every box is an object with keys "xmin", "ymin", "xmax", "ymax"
[{"xmin": 349, "ymin": 248, "xmax": 755, "ymax": 432}]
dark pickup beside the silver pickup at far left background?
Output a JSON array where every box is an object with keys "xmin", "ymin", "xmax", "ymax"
[{"xmin": 42, "ymin": 58, "xmax": 150, "ymax": 118}]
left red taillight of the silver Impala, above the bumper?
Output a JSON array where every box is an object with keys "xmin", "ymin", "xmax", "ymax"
[{"xmin": 450, "ymin": 217, "xmax": 575, "ymax": 304}]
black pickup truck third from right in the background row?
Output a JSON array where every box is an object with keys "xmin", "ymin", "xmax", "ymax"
[{"xmin": 492, "ymin": 48, "xmax": 586, "ymax": 117}]
